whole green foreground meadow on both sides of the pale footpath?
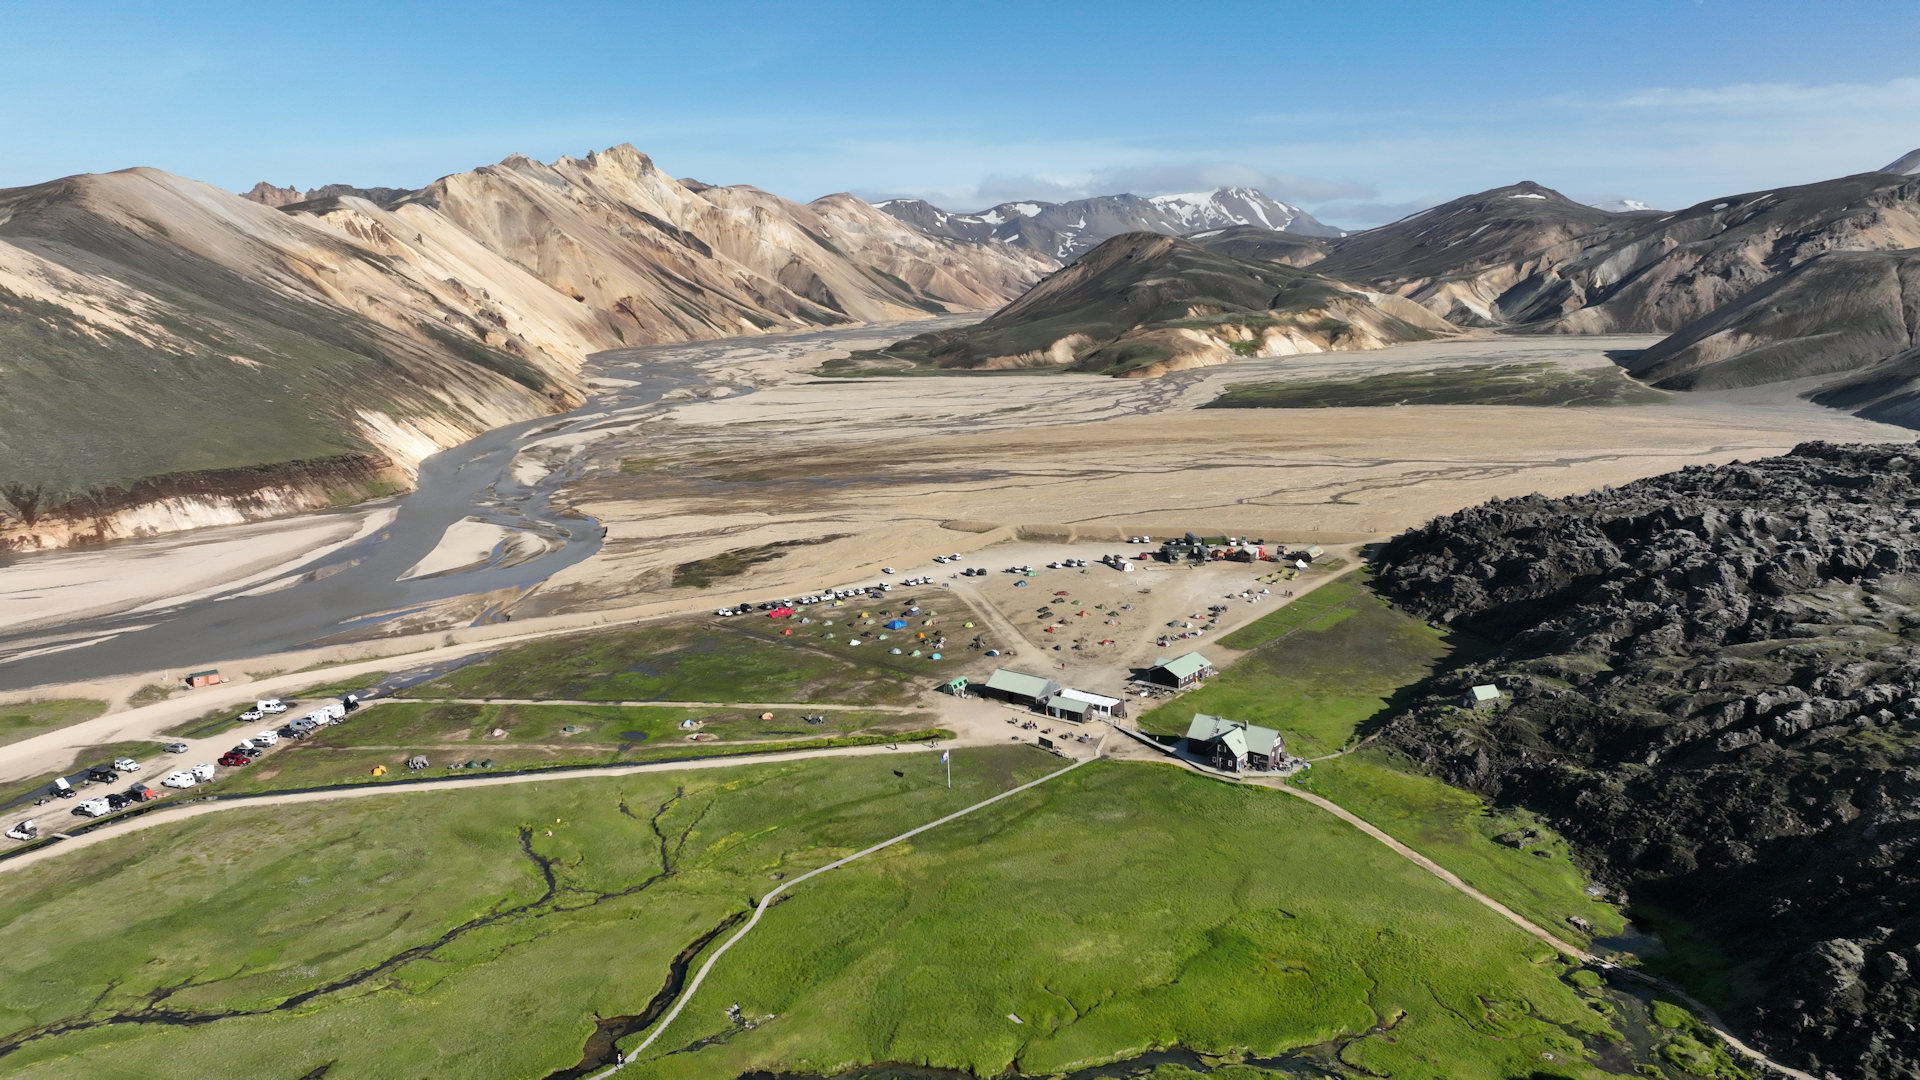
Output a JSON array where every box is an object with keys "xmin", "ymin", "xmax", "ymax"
[{"xmin": 0, "ymin": 746, "xmax": 1681, "ymax": 1080}]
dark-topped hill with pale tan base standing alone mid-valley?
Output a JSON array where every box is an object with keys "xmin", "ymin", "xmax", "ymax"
[{"xmin": 828, "ymin": 233, "xmax": 1453, "ymax": 379}]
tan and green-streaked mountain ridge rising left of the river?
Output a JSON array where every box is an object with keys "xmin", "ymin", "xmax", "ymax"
[{"xmin": 0, "ymin": 146, "xmax": 1054, "ymax": 548}]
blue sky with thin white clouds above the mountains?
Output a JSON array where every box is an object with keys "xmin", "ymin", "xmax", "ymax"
[{"xmin": 0, "ymin": 0, "xmax": 1920, "ymax": 227}]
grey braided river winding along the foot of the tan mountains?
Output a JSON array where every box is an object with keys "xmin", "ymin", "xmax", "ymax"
[{"xmin": 0, "ymin": 315, "xmax": 936, "ymax": 690}]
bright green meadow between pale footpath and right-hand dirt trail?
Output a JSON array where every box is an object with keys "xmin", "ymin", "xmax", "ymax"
[{"xmin": 637, "ymin": 763, "xmax": 1651, "ymax": 1080}]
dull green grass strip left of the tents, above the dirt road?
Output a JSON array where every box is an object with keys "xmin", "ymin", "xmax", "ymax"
[{"xmin": 401, "ymin": 618, "xmax": 958, "ymax": 705}]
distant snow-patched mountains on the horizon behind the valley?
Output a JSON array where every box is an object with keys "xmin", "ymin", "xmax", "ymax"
[{"xmin": 874, "ymin": 188, "xmax": 1344, "ymax": 261}]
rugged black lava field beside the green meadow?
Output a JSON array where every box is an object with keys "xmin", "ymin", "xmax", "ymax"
[{"xmin": 1375, "ymin": 444, "xmax": 1920, "ymax": 1080}]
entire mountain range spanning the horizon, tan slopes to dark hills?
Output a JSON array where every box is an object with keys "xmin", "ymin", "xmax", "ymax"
[{"xmin": 11, "ymin": 146, "xmax": 1920, "ymax": 548}]
